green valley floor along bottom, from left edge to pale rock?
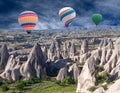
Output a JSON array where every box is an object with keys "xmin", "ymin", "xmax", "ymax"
[{"xmin": 0, "ymin": 81, "xmax": 77, "ymax": 93}]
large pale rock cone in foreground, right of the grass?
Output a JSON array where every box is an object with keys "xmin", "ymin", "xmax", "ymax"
[{"xmin": 76, "ymin": 57, "xmax": 98, "ymax": 92}]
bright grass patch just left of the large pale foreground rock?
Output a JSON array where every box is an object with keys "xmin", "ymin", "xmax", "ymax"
[{"xmin": 26, "ymin": 81, "xmax": 76, "ymax": 93}]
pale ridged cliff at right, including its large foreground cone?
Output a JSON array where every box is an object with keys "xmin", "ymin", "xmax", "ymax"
[{"xmin": 77, "ymin": 39, "xmax": 120, "ymax": 93}]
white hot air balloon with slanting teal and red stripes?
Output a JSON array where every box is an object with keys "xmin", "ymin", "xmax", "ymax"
[{"xmin": 59, "ymin": 7, "xmax": 76, "ymax": 28}]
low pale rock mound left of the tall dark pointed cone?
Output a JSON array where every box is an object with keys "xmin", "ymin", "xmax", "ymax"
[{"xmin": 0, "ymin": 55, "xmax": 21, "ymax": 82}]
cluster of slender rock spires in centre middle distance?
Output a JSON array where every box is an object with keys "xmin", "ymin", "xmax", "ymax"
[{"xmin": 48, "ymin": 41, "xmax": 76, "ymax": 61}]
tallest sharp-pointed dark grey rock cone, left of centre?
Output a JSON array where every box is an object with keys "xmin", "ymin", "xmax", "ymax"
[{"xmin": 20, "ymin": 43, "xmax": 45, "ymax": 80}]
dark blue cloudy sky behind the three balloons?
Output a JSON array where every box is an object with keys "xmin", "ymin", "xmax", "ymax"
[{"xmin": 0, "ymin": 0, "xmax": 120, "ymax": 30}]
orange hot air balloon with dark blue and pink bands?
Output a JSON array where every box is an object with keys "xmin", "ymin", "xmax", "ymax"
[{"xmin": 18, "ymin": 11, "xmax": 38, "ymax": 34}]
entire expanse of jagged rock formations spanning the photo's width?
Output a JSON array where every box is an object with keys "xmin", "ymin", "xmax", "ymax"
[{"xmin": 0, "ymin": 38, "xmax": 120, "ymax": 93}]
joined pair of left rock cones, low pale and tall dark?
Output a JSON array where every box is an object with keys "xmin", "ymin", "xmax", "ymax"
[{"xmin": 0, "ymin": 43, "xmax": 46, "ymax": 81}]
